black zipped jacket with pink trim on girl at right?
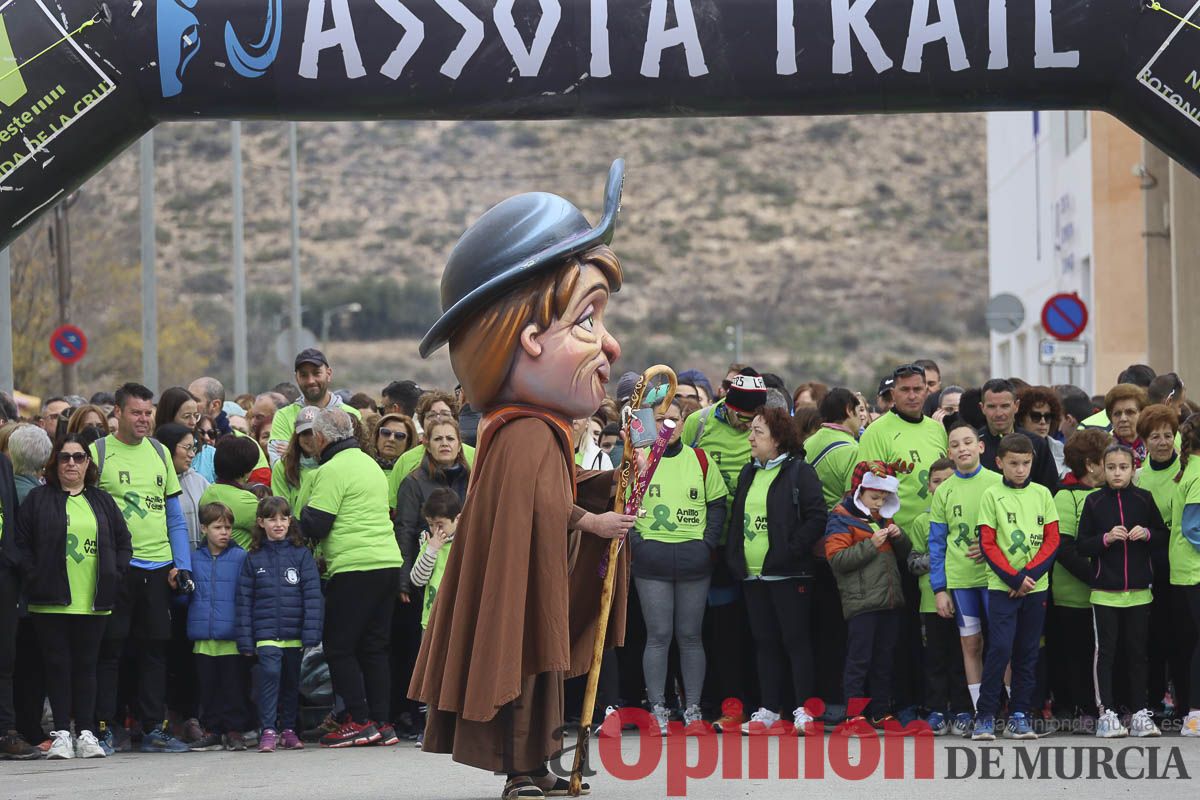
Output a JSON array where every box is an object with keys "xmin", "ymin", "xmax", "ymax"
[{"xmin": 1078, "ymin": 486, "xmax": 1170, "ymax": 591}]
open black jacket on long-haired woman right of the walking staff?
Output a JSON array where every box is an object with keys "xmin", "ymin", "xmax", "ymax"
[{"xmin": 725, "ymin": 456, "xmax": 827, "ymax": 581}]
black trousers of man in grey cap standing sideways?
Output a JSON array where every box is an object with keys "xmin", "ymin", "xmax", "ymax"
[{"xmin": 324, "ymin": 567, "xmax": 400, "ymax": 723}]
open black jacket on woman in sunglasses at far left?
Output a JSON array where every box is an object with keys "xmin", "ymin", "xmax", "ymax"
[{"xmin": 13, "ymin": 486, "xmax": 133, "ymax": 610}]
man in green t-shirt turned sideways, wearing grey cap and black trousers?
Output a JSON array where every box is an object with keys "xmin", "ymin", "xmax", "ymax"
[{"xmin": 300, "ymin": 408, "xmax": 403, "ymax": 747}]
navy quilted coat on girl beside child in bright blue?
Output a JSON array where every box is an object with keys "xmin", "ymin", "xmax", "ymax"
[{"xmin": 234, "ymin": 540, "xmax": 322, "ymax": 654}]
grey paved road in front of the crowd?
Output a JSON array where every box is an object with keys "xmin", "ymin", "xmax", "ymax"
[{"xmin": 0, "ymin": 734, "xmax": 1200, "ymax": 800}]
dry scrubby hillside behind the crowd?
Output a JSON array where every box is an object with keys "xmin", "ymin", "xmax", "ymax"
[{"xmin": 14, "ymin": 115, "xmax": 988, "ymax": 391}]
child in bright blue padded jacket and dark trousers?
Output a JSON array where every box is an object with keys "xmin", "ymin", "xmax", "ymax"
[{"xmin": 187, "ymin": 503, "xmax": 246, "ymax": 751}]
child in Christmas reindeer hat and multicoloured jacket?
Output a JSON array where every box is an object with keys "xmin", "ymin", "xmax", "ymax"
[{"xmin": 824, "ymin": 462, "xmax": 912, "ymax": 726}]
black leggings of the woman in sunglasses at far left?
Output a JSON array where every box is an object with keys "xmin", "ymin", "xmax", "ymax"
[{"xmin": 34, "ymin": 614, "xmax": 108, "ymax": 733}]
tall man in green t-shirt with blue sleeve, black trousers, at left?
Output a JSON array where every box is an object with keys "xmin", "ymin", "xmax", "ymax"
[{"xmin": 91, "ymin": 383, "xmax": 193, "ymax": 752}]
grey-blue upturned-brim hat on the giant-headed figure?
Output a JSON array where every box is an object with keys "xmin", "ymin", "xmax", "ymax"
[{"xmin": 420, "ymin": 158, "xmax": 625, "ymax": 357}]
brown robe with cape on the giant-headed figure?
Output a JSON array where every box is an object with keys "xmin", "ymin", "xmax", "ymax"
[{"xmin": 408, "ymin": 407, "xmax": 629, "ymax": 774}]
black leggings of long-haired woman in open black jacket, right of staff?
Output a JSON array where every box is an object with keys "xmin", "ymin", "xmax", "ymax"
[{"xmin": 742, "ymin": 578, "xmax": 812, "ymax": 711}]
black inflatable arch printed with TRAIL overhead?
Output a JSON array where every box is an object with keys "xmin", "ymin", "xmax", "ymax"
[{"xmin": 0, "ymin": 0, "xmax": 1200, "ymax": 246}]
